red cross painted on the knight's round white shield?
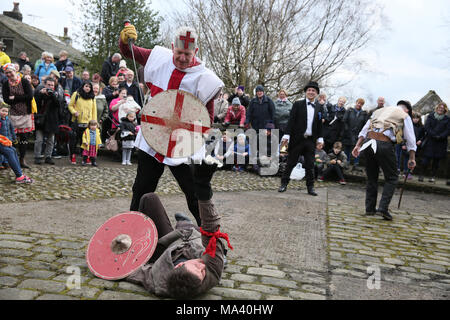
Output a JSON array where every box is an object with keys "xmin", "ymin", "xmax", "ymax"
[{"xmin": 141, "ymin": 91, "xmax": 210, "ymax": 158}]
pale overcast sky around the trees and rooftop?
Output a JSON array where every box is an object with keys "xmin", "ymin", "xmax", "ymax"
[{"xmin": 0, "ymin": 0, "xmax": 450, "ymax": 104}]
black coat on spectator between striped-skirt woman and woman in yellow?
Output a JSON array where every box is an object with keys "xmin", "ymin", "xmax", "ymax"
[{"xmin": 34, "ymin": 91, "xmax": 61, "ymax": 133}]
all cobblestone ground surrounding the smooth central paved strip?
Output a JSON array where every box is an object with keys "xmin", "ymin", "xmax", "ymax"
[{"xmin": 0, "ymin": 160, "xmax": 450, "ymax": 300}]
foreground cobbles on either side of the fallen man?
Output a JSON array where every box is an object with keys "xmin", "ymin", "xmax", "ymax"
[{"xmin": 0, "ymin": 230, "xmax": 327, "ymax": 300}]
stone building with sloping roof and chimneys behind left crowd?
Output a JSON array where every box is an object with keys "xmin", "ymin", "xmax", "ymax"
[{"xmin": 0, "ymin": 2, "xmax": 83, "ymax": 64}]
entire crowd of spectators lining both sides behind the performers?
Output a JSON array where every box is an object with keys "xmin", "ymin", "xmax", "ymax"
[{"xmin": 0, "ymin": 43, "xmax": 450, "ymax": 184}]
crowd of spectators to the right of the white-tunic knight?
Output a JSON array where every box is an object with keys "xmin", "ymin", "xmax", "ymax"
[{"xmin": 214, "ymin": 85, "xmax": 450, "ymax": 185}]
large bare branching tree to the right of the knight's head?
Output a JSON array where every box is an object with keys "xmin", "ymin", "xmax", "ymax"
[{"xmin": 174, "ymin": 0, "xmax": 383, "ymax": 97}]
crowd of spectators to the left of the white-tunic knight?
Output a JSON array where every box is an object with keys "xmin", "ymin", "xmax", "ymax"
[{"xmin": 0, "ymin": 48, "xmax": 144, "ymax": 183}]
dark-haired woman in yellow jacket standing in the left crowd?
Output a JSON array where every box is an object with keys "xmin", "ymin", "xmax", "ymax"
[{"xmin": 68, "ymin": 82, "xmax": 97, "ymax": 164}]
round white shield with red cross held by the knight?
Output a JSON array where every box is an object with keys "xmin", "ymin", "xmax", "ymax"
[{"xmin": 141, "ymin": 90, "xmax": 211, "ymax": 158}]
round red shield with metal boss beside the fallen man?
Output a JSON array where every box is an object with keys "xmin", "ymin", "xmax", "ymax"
[{"xmin": 86, "ymin": 211, "xmax": 158, "ymax": 280}]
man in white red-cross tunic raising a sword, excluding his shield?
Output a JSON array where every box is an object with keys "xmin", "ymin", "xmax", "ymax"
[{"xmin": 119, "ymin": 25, "xmax": 224, "ymax": 226}]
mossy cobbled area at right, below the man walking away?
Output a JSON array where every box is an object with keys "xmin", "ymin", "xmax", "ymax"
[{"xmin": 328, "ymin": 202, "xmax": 450, "ymax": 299}]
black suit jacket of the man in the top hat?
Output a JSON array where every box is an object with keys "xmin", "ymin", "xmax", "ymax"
[{"xmin": 286, "ymin": 99, "xmax": 323, "ymax": 146}]
